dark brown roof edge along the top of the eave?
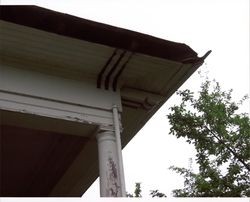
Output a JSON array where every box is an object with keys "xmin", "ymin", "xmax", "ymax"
[{"xmin": 0, "ymin": 6, "xmax": 203, "ymax": 63}]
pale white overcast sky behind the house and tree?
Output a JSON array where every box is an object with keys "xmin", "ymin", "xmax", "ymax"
[{"xmin": 0, "ymin": 0, "xmax": 250, "ymax": 199}]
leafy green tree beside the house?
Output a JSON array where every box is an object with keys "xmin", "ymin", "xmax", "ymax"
[{"xmin": 167, "ymin": 79, "xmax": 250, "ymax": 197}]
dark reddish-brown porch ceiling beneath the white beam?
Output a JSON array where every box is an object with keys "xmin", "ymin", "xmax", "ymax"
[{"xmin": 0, "ymin": 125, "xmax": 88, "ymax": 197}]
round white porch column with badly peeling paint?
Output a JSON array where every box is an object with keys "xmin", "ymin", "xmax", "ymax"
[{"xmin": 97, "ymin": 130, "xmax": 122, "ymax": 197}]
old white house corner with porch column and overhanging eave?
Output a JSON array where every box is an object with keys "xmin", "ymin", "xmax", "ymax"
[{"xmin": 0, "ymin": 6, "xmax": 210, "ymax": 197}]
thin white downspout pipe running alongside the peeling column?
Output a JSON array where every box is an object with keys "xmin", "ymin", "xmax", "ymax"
[{"xmin": 112, "ymin": 105, "xmax": 126, "ymax": 197}]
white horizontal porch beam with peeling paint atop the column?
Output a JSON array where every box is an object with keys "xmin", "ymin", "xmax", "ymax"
[{"xmin": 0, "ymin": 64, "xmax": 122, "ymax": 125}]
